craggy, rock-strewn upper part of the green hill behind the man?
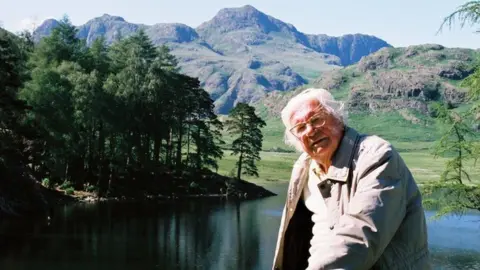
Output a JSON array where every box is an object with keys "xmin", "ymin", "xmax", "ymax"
[{"xmin": 255, "ymin": 44, "xmax": 478, "ymax": 119}]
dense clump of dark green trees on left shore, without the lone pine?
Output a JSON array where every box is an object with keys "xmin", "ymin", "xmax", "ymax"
[{"xmin": 0, "ymin": 17, "xmax": 231, "ymax": 198}]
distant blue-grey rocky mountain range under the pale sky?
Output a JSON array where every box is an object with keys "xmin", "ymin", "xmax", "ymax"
[{"xmin": 34, "ymin": 5, "xmax": 391, "ymax": 113}]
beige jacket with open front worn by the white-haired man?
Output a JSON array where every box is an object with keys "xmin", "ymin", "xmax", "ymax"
[{"xmin": 273, "ymin": 127, "xmax": 431, "ymax": 270}]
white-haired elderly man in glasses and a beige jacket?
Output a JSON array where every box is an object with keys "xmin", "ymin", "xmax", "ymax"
[{"xmin": 273, "ymin": 89, "xmax": 431, "ymax": 270}]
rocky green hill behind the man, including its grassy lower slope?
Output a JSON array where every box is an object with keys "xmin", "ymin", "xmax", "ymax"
[{"xmin": 249, "ymin": 44, "xmax": 478, "ymax": 151}]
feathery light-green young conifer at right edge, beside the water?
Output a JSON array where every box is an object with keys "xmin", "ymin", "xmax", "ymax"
[{"xmin": 423, "ymin": 101, "xmax": 480, "ymax": 218}]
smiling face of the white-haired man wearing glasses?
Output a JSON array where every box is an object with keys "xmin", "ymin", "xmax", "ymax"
[{"xmin": 290, "ymin": 100, "xmax": 343, "ymax": 161}]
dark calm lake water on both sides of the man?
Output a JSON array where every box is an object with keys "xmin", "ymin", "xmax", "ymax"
[{"xmin": 0, "ymin": 184, "xmax": 480, "ymax": 270}]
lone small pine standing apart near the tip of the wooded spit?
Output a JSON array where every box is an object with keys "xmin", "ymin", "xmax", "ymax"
[{"xmin": 225, "ymin": 103, "xmax": 266, "ymax": 180}]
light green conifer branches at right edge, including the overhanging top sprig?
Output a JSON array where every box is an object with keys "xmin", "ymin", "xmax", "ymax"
[{"xmin": 423, "ymin": 1, "xmax": 480, "ymax": 217}]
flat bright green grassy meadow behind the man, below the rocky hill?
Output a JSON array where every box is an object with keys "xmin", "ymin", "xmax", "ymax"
[{"xmin": 218, "ymin": 112, "xmax": 480, "ymax": 187}]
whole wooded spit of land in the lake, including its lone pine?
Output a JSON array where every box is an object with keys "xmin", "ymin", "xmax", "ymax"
[{"xmin": 0, "ymin": 18, "xmax": 275, "ymax": 220}]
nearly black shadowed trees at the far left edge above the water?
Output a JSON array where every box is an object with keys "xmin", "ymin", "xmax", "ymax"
[{"xmin": 0, "ymin": 28, "xmax": 54, "ymax": 219}]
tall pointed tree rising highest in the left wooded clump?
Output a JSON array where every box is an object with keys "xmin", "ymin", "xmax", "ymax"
[{"xmin": 20, "ymin": 17, "xmax": 91, "ymax": 188}]
